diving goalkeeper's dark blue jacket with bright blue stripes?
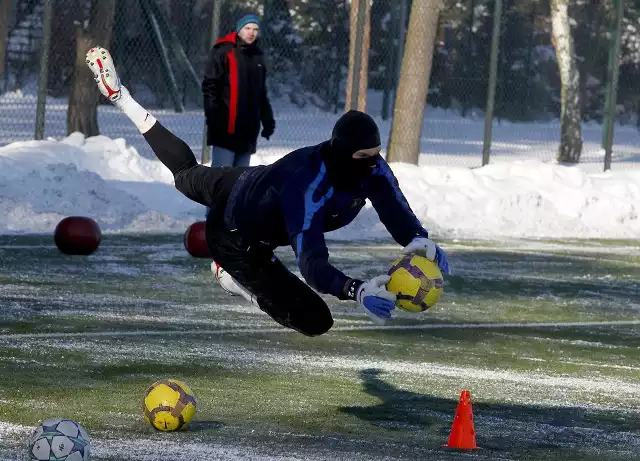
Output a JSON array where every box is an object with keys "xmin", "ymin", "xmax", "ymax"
[{"xmin": 224, "ymin": 143, "xmax": 428, "ymax": 299}]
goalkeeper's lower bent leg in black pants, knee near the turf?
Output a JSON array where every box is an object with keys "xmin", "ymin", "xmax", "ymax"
[{"xmin": 207, "ymin": 217, "xmax": 333, "ymax": 336}]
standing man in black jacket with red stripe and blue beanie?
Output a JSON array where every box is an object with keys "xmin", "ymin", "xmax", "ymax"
[{"xmin": 202, "ymin": 14, "xmax": 275, "ymax": 166}]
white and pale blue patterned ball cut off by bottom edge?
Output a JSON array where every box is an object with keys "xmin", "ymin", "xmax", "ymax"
[{"xmin": 27, "ymin": 418, "xmax": 89, "ymax": 461}]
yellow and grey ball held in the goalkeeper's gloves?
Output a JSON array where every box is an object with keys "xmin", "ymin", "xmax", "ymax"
[{"xmin": 387, "ymin": 255, "xmax": 444, "ymax": 312}]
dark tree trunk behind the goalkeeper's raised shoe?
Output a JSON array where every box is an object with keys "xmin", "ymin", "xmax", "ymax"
[{"xmin": 67, "ymin": 0, "xmax": 116, "ymax": 136}]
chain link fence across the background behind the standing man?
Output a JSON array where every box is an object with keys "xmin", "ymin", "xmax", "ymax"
[{"xmin": 0, "ymin": 0, "xmax": 640, "ymax": 167}]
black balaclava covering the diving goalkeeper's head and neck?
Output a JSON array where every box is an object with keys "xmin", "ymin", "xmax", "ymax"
[{"xmin": 322, "ymin": 110, "xmax": 380, "ymax": 189}]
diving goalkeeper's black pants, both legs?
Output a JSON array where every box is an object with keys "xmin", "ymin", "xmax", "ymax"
[{"xmin": 144, "ymin": 122, "xmax": 333, "ymax": 336}]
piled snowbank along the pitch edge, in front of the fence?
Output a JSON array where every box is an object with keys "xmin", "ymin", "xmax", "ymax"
[{"xmin": 0, "ymin": 126, "xmax": 640, "ymax": 239}]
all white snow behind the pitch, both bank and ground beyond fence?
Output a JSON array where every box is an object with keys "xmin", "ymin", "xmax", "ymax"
[{"xmin": 0, "ymin": 94, "xmax": 640, "ymax": 239}]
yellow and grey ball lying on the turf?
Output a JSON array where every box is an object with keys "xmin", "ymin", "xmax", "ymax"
[{"xmin": 143, "ymin": 379, "xmax": 197, "ymax": 431}]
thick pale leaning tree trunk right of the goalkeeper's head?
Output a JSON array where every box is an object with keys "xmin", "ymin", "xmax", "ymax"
[{"xmin": 387, "ymin": 0, "xmax": 444, "ymax": 165}]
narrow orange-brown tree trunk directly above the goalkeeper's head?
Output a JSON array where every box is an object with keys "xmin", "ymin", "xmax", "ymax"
[{"xmin": 345, "ymin": 0, "xmax": 371, "ymax": 112}]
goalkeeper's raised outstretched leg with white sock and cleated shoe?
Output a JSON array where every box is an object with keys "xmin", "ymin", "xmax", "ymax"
[{"xmin": 86, "ymin": 46, "xmax": 242, "ymax": 206}]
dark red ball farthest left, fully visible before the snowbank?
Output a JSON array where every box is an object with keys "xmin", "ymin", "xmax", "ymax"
[{"xmin": 53, "ymin": 216, "xmax": 102, "ymax": 255}]
